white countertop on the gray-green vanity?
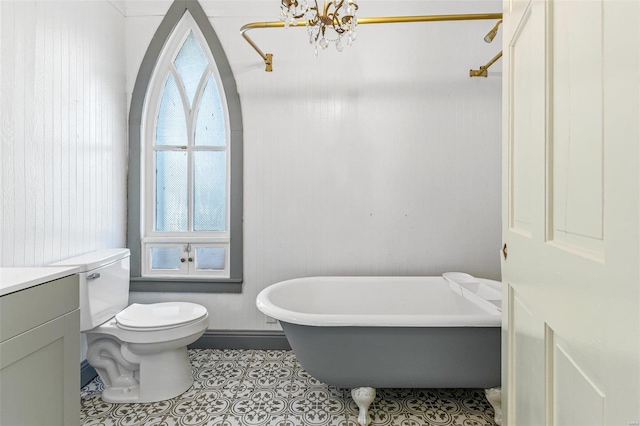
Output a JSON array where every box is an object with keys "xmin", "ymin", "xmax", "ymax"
[{"xmin": 0, "ymin": 266, "xmax": 79, "ymax": 296}]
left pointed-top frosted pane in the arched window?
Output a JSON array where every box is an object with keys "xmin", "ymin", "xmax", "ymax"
[{"xmin": 156, "ymin": 74, "xmax": 187, "ymax": 146}]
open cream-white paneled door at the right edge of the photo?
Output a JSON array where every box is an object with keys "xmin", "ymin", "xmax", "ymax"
[{"xmin": 502, "ymin": 0, "xmax": 640, "ymax": 426}]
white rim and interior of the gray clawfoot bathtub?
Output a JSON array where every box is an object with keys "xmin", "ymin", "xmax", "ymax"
[{"xmin": 257, "ymin": 273, "xmax": 501, "ymax": 326}]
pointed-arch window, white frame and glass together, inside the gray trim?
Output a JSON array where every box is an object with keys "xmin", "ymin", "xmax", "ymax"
[{"xmin": 141, "ymin": 12, "xmax": 231, "ymax": 278}]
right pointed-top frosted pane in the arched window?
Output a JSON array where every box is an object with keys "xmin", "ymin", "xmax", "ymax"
[{"xmin": 195, "ymin": 74, "xmax": 227, "ymax": 146}]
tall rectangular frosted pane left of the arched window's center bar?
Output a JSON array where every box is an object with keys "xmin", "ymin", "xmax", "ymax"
[{"xmin": 156, "ymin": 151, "xmax": 189, "ymax": 231}]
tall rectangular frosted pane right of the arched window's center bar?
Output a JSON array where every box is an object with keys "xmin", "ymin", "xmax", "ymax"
[{"xmin": 193, "ymin": 151, "xmax": 227, "ymax": 231}]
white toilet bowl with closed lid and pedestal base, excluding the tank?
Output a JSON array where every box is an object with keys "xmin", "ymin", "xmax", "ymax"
[{"xmin": 86, "ymin": 302, "xmax": 209, "ymax": 403}]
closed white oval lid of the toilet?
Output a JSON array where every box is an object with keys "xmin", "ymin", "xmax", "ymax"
[{"xmin": 116, "ymin": 302, "xmax": 207, "ymax": 330}]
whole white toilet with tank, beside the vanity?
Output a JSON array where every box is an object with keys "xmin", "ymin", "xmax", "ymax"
[{"xmin": 55, "ymin": 249, "xmax": 209, "ymax": 403}]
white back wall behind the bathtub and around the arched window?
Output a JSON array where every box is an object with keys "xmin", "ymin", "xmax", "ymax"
[{"xmin": 126, "ymin": 0, "xmax": 501, "ymax": 330}]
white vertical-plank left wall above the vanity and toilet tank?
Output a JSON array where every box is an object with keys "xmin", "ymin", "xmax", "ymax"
[{"xmin": 0, "ymin": 0, "xmax": 127, "ymax": 266}]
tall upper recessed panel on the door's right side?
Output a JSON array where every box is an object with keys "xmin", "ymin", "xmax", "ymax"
[{"xmin": 547, "ymin": 1, "xmax": 604, "ymax": 255}]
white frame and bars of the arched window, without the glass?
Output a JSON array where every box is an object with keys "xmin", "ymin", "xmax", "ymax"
[{"xmin": 140, "ymin": 11, "xmax": 231, "ymax": 278}]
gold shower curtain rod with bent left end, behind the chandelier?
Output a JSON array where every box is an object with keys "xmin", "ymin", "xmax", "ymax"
[{"xmin": 240, "ymin": 13, "xmax": 502, "ymax": 72}]
